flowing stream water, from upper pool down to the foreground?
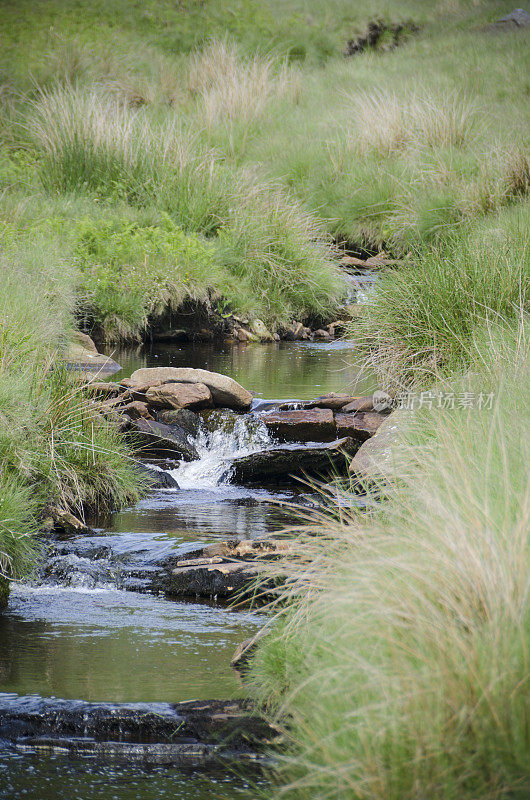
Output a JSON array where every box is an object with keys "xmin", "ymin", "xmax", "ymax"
[{"xmin": 0, "ymin": 342, "xmax": 373, "ymax": 800}]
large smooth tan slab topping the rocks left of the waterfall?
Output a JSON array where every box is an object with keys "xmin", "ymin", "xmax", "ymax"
[{"xmin": 130, "ymin": 367, "xmax": 252, "ymax": 411}]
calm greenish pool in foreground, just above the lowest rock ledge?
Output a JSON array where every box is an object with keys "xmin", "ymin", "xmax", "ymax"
[{"xmin": 0, "ymin": 587, "xmax": 265, "ymax": 702}]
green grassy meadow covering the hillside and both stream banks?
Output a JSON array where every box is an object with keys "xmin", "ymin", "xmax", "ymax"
[{"xmin": 0, "ymin": 0, "xmax": 530, "ymax": 800}]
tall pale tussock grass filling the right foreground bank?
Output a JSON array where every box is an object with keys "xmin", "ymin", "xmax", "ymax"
[{"xmin": 251, "ymin": 322, "xmax": 530, "ymax": 800}]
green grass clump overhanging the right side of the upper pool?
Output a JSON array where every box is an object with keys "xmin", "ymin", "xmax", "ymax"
[{"xmin": 352, "ymin": 203, "xmax": 530, "ymax": 384}]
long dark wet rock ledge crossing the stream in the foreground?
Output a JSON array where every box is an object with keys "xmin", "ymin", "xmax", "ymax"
[{"xmin": 0, "ymin": 694, "xmax": 276, "ymax": 763}]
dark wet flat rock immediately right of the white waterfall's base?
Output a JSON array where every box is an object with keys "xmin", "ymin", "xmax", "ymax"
[{"xmin": 230, "ymin": 438, "xmax": 358, "ymax": 483}]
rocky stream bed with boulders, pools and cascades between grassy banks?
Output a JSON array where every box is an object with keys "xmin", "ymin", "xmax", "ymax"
[{"xmin": 0, "ymin": 334, "xmax": 385, "ymax": 800}]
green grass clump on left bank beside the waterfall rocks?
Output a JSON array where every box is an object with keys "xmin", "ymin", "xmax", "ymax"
[{"xmin": 0, "ymin": 228, "xmax": 144, "ymax": 578}]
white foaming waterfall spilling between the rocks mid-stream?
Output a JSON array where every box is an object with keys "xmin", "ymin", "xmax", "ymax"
[{"xmin": 171, "ymin": 411, "xmax": 272, "ymax": 489}]
